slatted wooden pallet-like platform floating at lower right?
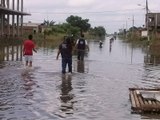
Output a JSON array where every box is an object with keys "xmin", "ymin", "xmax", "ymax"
[{"xmin": 129, "ymin": 88, "xmax": 160, "ymax": 113}]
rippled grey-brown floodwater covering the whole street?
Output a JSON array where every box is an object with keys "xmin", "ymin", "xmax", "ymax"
[{"xmin": 0, "ymin": 38, "xmax": 160, "ymax": 120}]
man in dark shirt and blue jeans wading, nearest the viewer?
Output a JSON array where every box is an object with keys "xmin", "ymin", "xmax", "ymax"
[{"xmin": 56, "ymin": 37, "xmax": 72, "ymax": 74}]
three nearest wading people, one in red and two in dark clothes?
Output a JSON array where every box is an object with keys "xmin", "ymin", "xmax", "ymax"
[{"xmin": 23, "ymin": 34, "xmax": 89, "ymax": 74}]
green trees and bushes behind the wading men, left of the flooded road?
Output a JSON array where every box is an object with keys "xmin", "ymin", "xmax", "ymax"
[{"xmin": 41, "ymin": 15, "xmax": 106, "ymax": 41}]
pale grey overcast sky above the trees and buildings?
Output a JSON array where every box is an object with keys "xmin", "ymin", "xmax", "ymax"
[{"xmin": 24, "ymin": 0, "xmax": 160, "ymax": 33}]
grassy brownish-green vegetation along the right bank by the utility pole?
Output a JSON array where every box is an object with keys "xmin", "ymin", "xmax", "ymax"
[{"xmin": 119, "ymin": 27, "xmax": 160, "ymax": 61}]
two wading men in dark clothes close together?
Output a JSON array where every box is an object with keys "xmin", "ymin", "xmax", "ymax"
[{"xmin": 57, "ymin": 34, "xmax": 89, "ymax": 74}]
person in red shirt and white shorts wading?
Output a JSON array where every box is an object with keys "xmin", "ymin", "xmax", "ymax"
[{"xmin": 23, "ymin": 35, "xmax": 37, "ymax": 67}]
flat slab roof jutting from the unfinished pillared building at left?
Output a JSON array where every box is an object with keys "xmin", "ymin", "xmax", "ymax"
[{"xmin": 0, "ymin": 6, "xmax": 31, "ymax": 15}]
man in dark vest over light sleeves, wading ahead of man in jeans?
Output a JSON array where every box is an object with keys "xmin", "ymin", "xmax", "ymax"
[{"xmin": 75, "ymin": 34, "xmax": 89, "ymax": 61}]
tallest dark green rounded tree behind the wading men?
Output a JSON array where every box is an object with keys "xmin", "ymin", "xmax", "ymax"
[{"xmin": 66, "ymin": 15, "xmax": 91, "ymax": 34}]
